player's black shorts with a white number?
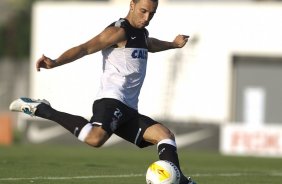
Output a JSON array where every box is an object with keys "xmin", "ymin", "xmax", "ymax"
[{"xmin": 90, "ymin": 98, "xmax": 157, "ymax": 148}]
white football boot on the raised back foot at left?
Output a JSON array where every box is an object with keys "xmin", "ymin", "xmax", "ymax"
[{"xmin": 9, "ymin": 97, "xmax": 50, "ymax": 116}]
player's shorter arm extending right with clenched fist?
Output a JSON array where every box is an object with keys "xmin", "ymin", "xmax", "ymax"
[{"xmin": 148, "ymin": 35, "xmax": 189, "ymax": 52}]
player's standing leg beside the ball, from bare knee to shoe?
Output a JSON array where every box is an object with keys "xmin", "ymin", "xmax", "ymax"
[{"xmin": 143, "ymin": 124, "xmax": 196, "ymax": 184}]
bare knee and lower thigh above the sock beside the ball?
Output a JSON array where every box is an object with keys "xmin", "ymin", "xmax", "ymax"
[{"xmin": 143, "ymin": 123, "xmax": 174, "ymax": 144}]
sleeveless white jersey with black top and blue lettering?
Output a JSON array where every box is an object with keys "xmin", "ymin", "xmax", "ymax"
[{"xmin": 97, "ymin": 19, "xmax": 148, "ymax": 110}]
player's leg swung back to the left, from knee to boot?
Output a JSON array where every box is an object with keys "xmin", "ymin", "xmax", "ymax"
[{"xmin": 10, "ymin": 97, "xmax": 109, "ymax": 147}]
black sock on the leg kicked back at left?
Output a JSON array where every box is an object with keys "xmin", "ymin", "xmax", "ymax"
[{"xmin": 35, "ymin": 103, "xmax": 89, "ymax": 137}]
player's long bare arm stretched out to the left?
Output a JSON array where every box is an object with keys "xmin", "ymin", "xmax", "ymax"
[{"xmin": 36, "ymin": 27, "xmax": 126, "ymax": 71}]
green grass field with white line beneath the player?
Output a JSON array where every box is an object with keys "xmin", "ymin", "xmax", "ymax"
[{"xmin": 0, "ymin": 145, "xmax": 282, "ymax": 184}]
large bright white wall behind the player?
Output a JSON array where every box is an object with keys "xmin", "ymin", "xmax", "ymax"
[{"xmin": 30, "ymin": 2, "xmax": 282, "ymax": 123}]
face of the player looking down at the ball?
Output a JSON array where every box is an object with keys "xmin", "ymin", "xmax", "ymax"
[{"xmin": 130, "ymin": 0, "xmax": 158, "ymax": 28}]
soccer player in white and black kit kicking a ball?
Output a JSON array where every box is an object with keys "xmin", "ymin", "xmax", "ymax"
[{"xmin": 10, "ymin": 0, "xmax": 195, "ymax": 184}]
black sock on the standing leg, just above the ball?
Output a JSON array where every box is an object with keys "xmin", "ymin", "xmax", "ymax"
[{"xmin": 158, "ymin": 140, "xmax": 181, "ymax": 171}]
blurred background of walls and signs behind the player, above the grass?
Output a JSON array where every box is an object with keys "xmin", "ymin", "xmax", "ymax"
[{"xmin": 0, "ymin": 0, "xmax": 282, "ymax": 157}]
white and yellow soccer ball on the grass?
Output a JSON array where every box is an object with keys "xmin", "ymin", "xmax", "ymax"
[{"xmin": 146, "ymin": 160, "xmax": 180, "ymax": 184}]
